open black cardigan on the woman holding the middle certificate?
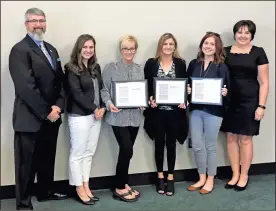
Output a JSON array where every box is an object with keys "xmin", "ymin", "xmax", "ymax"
[{"xmin": 144, "ymin": 58, "xmax": 189, "ymax": 144}]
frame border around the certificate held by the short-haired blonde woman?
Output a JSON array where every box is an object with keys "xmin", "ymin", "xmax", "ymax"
[{"xmin": 112, "ymin": 80, "xmax": 148, "ymax": 109}]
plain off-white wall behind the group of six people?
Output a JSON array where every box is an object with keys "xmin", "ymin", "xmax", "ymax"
[{"xmin": 1, "ymin": 1, "xmax": 275, "ymax": 185}]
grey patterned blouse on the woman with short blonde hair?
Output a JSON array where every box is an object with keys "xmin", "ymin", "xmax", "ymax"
[{"xmin": 101, "ymin": 60, "xmax": 144, "ymax": 127}]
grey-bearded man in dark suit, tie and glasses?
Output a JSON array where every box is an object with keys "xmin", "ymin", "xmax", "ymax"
[{"xmin": 9, "ymin": 8, "xmax": 67, "ymax": 209}]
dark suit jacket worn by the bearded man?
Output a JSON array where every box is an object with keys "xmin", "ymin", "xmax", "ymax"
[{"xmin": 9, "ymin": 35, "xmax": 65, "ymax": 132}]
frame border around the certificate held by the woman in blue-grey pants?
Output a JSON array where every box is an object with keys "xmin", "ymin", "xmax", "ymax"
[{"xmin": 191, "ymin": 77, "xmax": 223, "ymax": 106}]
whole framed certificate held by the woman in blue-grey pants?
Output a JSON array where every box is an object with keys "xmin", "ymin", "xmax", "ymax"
[{"xmin": 191, "ymin": 78, "xmax": 223, "ymax": 105}]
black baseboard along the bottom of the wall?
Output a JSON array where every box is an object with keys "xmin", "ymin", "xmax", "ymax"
[{"xmin": 0, "ymin": 162, "xmax": 276, "ymax": 199}]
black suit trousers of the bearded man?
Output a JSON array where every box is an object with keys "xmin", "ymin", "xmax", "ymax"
[{"xmin": 14, "ymin": 120, "xmax": 60, "ymax": 206}]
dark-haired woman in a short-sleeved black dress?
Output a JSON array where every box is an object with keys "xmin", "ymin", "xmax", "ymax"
[{"xmin": 222, "ymin": 20, "xmax": 269, "ymax": 191}]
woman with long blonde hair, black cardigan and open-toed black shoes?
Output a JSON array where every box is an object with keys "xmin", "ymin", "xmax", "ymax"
[{"xmin": 144, "ymin": 33, "xmax": 188, "ymax": 196}]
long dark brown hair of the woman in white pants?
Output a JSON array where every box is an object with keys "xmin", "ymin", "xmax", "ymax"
[{"xmin": 65, "ymin": 34, "xmax": 97, "ymax": 77}]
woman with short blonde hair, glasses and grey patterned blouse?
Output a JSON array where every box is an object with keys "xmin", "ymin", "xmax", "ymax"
[{"xmin": 101, "ymin": 35, "xmax": 144, "ymax": 202}]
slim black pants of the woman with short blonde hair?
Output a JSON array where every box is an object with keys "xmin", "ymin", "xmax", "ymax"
[{"xmin": 112, "ymin": 126, "xmax": 139, "ymax": 189}]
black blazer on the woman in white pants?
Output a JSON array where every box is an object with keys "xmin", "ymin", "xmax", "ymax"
[{"xmin": 65, "ymin": 64, "xmax": 104, "ymax": 116}]
